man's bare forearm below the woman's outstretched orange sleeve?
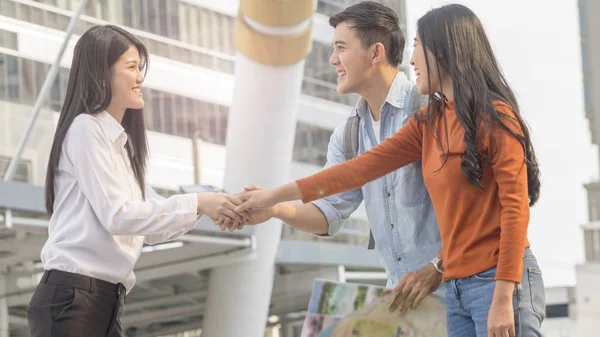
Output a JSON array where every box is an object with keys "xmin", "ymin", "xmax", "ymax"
[{"xmin": 272, "ymin": 201, "xmax": 329, "ymax": 234}]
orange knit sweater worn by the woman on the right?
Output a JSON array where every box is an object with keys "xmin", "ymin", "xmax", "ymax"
[{"xmin": 297, "ymin": 102, "xmax": 529, "ymax": 283}]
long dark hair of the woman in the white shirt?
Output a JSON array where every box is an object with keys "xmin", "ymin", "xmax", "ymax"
[{"xmin": 46, "ymin": 25, "xmax": 148, "ymax": 215}]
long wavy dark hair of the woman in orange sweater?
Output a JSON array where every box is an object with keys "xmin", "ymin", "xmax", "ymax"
[{"xmin": 417, "ymin": 4, "xmax": 540, "ymax": 206}]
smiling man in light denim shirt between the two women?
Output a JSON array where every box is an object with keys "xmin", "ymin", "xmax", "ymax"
[{"xmin": 227, "ymin": 1, "xmax": 441, "ymax": 312}]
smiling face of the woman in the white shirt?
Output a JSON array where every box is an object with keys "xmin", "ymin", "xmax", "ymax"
[{"xmin": 110, "ymin": 46, "xmax": 144, "ymax": 109}]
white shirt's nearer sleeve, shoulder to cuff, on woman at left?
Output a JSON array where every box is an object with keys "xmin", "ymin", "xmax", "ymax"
[{"xmin": 64, "ymin": 118, "xmax": 198, "ymax": 235}]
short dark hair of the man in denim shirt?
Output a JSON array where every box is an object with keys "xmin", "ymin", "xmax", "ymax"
[{"xmin": 329, "ymin": 1, "xmax": 405, "ymax": 67}]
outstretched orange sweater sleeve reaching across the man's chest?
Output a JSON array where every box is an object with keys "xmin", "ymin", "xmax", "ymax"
[{"xmin": 296, "ymin": 119, "xmax": 422, "ymax": 203}]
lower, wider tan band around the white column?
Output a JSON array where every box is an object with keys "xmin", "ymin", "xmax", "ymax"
[{"xmin": 235, "ymin": 9, "xmax": 312, "ymax": 66}]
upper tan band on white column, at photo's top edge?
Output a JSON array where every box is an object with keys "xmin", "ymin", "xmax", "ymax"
[{"xmin": 240, "ymin": 0, "xmax": 316, "ymax": 27}]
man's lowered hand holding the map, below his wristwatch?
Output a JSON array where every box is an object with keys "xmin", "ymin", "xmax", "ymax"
[{"xmin": 390, "ymin": 263, "xmax": 442, "ymax": 315}]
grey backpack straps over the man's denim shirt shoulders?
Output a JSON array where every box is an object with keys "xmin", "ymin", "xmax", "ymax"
[{"xmin": 343, "ymin": 85, "xmax": 427, "ymax": 250}]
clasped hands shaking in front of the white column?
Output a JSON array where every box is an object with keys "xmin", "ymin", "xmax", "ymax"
[{"xmin": 198, "ymin": 185, "xmax": 276, "ymax": 232}]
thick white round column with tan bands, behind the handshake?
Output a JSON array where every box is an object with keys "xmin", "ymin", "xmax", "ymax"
[{"xmin": 202, "ymin": 0, "xmax": 315, "ymax": 337}]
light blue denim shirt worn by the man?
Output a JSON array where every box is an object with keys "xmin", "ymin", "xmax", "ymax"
[{"xmin": 313, "ymin": 72, "xmax": 441, "ymax": 287}]
